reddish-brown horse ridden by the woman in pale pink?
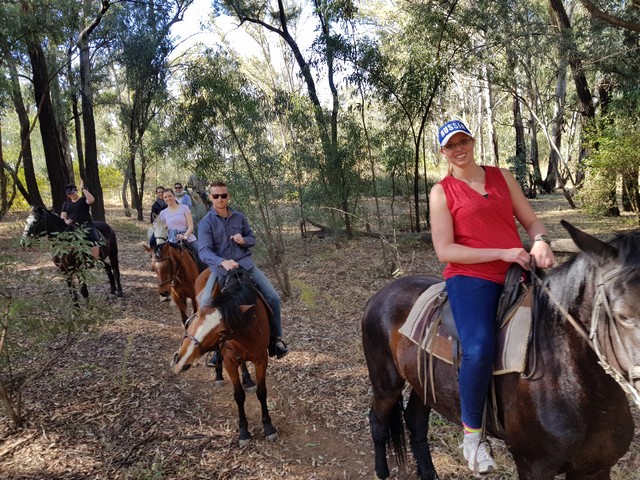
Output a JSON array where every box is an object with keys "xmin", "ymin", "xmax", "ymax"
[{"xmin": 144, "ymin": 221, "xmax": 206, "ymax": 325}]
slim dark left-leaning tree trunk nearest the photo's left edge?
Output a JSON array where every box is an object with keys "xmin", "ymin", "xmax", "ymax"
[{"xmin": 7, "ymin": 56, "xmax": 44, "ymax": 207}]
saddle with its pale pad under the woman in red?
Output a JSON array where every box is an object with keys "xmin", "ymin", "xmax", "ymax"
[{"xmin": 399, "ymin": 264, "xmax": 533, "ymax": 400}]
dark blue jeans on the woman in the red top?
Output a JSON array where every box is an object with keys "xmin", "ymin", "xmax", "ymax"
[{"xmin": 447, "ymin": 275, "xmax": 503, "ymax": 428}]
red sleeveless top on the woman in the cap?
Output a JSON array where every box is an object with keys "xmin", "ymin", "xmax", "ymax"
[{"xmin": 440, "ymin": 166, "xmax": 522, "ymax": 283}]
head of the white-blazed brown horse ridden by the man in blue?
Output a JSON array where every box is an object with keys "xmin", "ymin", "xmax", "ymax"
[{"xmin": 171, "ymin": 274, "xmax": 255, "ymax": 373}]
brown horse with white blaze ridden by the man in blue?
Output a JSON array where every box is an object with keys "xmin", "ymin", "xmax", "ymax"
[{"xmin": 172, "ymin": 269, "xmax": 278, "ymax": 446}]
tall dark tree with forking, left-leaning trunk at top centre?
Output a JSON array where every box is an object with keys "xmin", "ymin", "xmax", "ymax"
[{"xmin": 214, "ymin": 0, "xmax": 362, "ymax": 237}]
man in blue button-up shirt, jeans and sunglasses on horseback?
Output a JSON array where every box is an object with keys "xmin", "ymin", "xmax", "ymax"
[{"xmin": 198, "ymin": 182, "xmax": 289, "ymax": 364}]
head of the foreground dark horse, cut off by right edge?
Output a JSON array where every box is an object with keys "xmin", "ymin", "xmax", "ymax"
[{"xmin": 561, "ymin": 221, "xmax": 640, "ymax": 401}]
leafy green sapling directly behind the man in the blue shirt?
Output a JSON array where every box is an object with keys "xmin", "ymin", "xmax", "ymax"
[{"xmin": 172, "ymin": 51, "xmax": 292, "ymax": 296}]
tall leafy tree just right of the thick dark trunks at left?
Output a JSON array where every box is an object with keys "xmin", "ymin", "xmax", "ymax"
[{"xmin": 112, "ymin": 0, "xmax": 193, "ymax": 220}]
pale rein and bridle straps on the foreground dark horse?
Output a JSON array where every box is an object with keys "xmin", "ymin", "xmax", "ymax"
[{"xmin": 533, "ymin": 267, "xmax": 640, "ymax": 407}]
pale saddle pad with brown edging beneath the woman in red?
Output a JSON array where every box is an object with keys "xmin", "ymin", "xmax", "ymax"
[{"xmin": 399, "ymin": 282, "xmax": 532, "ymax": 375}]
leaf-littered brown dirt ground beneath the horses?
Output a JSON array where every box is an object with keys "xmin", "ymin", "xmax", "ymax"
[{"xmin": 0, "ymin": 198, "xmax": 640, "ymax": 480}]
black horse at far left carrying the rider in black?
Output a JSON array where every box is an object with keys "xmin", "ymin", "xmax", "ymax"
[{"xmin": 20, "ymin": 207, "xmax": 122, "ymax": 298}]
